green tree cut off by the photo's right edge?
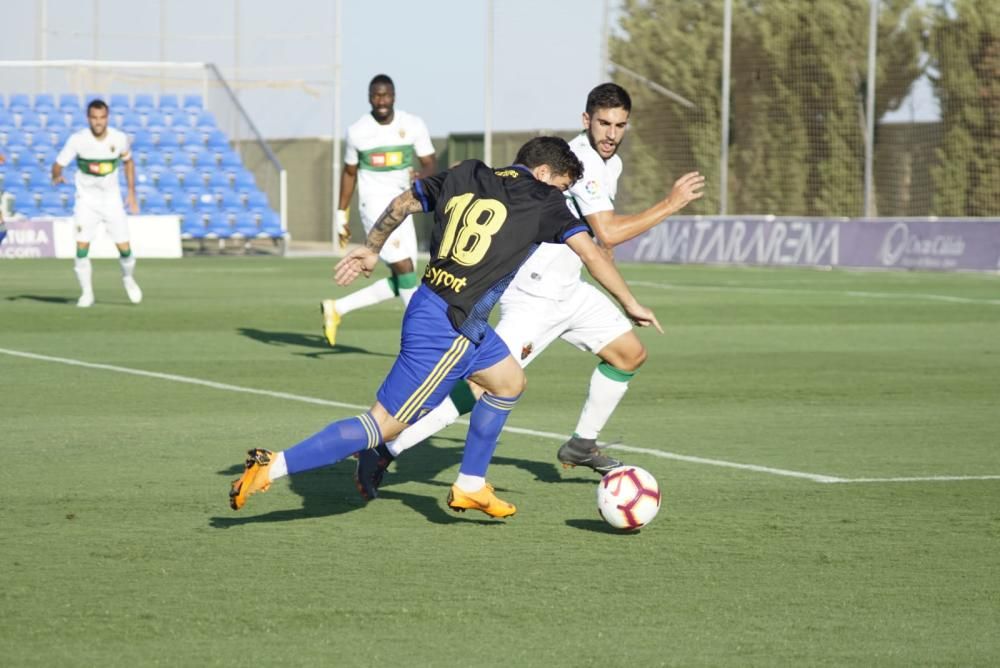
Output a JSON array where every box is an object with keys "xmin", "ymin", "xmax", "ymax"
[{"xmin": 931, "ymin": 0, "xmax": 1000, "ymax": 216}]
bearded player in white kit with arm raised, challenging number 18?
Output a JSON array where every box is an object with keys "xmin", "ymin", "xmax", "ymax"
[{"xmin": 355, "ymin": 83, "xmax": 705, "ymax": 499}]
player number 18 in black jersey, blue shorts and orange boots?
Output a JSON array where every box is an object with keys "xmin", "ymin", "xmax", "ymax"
[{"xmin": 229, "ymin": 137, "xmax": 663, "ymax": 517}]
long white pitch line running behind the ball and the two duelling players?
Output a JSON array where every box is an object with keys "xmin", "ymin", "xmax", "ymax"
[{"xmin": 0, "ymin": 348, "xmax": 1000, "ymax": 483}]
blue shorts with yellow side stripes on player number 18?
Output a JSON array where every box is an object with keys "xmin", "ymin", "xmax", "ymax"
[{"xmin": 376, "ymin": 285, "xmax": 510, "ymax": 424}]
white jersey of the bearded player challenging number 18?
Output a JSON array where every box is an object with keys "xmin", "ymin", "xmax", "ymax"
[{"xmin": 511, "ymin": 132, "xmax": 622, "ymax": 299}]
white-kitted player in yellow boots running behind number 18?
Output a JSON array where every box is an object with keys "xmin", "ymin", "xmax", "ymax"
[{"xmin": 320, "ymin": 74, "xmax": 437, "ymax": 346}]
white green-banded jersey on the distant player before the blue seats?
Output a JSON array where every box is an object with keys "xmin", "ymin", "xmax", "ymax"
[{"xmin": 56, "ymin": 128, "xmax": 132, "ymax": 198}]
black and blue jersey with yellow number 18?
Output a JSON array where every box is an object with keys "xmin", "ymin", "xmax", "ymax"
[{"xmin": 413, "ymin": 160, "xmax": 589, "ymax": 341}]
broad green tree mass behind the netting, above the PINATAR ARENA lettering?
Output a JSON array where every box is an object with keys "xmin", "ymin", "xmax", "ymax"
[{"xmin": 611, "ymin": 0, "xmax": 925, "ymax": 216}]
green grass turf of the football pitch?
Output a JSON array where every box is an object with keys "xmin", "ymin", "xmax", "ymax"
[{"xmin": 0, "ymin": 258, "xmax": 1000, "ymax": 666}]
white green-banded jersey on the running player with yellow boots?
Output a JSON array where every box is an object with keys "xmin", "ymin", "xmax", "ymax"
[{"xmin": 344, "ymin": 109, "xmax": 434, "ymax": 219}]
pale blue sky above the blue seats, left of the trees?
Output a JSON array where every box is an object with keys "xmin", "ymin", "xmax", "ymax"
[{"xmin": 0, "ymin": 0, "xmax": 618, "ymax": 138}]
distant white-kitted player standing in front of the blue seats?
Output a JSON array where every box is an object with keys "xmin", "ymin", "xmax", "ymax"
[{"xmin": 52, "ymin": 100, "xmax": 142, "ymax": 308}]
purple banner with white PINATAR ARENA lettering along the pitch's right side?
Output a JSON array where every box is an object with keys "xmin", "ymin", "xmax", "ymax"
[{"xmin": 615, "ymin": 216, "xmax": 1000, "ymax": 271}]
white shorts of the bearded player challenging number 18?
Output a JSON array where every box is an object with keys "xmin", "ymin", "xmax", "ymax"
[{"xmin": 495, "ymin": 281, "xmax": 632, "ymax": 367}]
